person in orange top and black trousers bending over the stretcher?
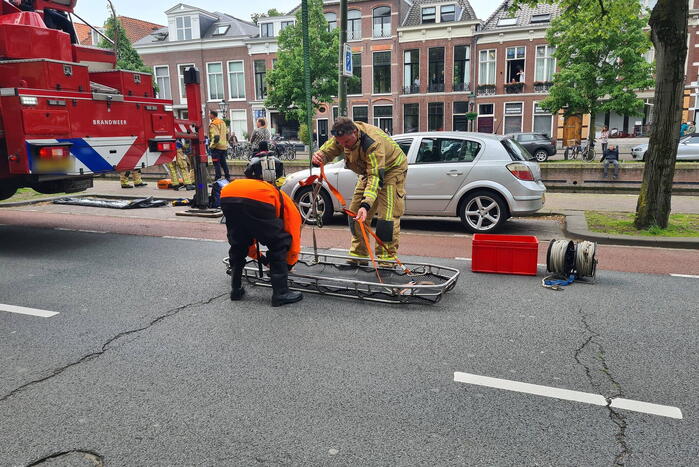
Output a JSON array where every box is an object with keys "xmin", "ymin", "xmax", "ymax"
[{"xmin": 221, "ymin": 156, "xmax": 303, "ymax": 306}]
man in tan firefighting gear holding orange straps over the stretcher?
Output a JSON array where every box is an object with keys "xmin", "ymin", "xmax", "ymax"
[{"xmin": 313, "ymin": 117, "xmax": 408, "ymax": 264}]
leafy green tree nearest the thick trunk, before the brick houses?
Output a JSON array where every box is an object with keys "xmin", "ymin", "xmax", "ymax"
[{"xmin": 541, "ymin": 0, "xmax": 653, "ymax": 152}]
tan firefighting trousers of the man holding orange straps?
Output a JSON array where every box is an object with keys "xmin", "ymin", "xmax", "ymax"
[{"xmin": 349, "ymin": 171, "xmax": 406, "ymax": 260}]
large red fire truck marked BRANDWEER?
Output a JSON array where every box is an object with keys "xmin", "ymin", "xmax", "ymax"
[{"xmin": 0, "ymin": 0, "xmax": 177, "ymax": 200}]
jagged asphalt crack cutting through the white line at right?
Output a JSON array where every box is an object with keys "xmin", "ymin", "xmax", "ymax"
[{"xmin": 575, "ymin": 308, "xmax": 633, "ymax": 466}]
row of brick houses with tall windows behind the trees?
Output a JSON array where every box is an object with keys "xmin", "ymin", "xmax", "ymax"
[{"xmin": 134, "ymin": 0, "xmax": 699, "ymax": 144}]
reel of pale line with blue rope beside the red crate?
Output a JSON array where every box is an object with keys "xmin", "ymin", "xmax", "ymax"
[{"xmin": 542, "ymin": 239, "xmax": 597, "ymax": 290}]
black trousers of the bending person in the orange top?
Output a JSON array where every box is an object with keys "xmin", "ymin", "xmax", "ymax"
[{"xmin": 221, "ymin": 198, "xmax": 291, "ymax": 276}]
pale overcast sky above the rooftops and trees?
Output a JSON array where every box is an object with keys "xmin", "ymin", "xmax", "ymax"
[{"xmin": 75, "ymin": 0, "xmax": 502, "ymax": 26}]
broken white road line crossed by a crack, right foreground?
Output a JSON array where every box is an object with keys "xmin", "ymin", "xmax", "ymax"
[{"xmin": 454, "ymin": 371, "xmax": 682, "ymax": 420}]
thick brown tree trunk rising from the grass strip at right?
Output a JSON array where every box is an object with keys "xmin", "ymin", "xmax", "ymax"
[{"xmin": 634, "ymin": 0, "xmax": 689, "ymax": 229}]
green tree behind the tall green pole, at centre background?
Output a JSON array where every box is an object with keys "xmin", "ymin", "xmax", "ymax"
[{"xmin": 265, "ymin": 0, "xmax": 340, "ymax": 126}]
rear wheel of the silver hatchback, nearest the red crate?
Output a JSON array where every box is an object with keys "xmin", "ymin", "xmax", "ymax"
[{"xmin": 459, "ymin": 191, "xmax": 508, "ymax": 233}]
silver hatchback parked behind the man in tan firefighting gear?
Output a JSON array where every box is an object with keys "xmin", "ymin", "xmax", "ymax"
[{"xmin": 282, "ymin": 132, "xmax": 546, "ymax": 233}]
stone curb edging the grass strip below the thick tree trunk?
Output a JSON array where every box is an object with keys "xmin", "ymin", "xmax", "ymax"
[{"xmin": 562, "ymin": 211, "xmax": 699, "ymax": 250}]
